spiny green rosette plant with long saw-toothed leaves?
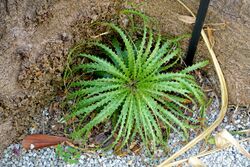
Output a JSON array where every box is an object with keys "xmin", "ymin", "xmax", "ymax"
[{"xmin": 64, "ymin": 10, "xmax": 207, "ymax": 151}]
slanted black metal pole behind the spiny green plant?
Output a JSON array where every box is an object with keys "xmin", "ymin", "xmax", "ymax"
[{"xmin": 185, "ymin": 0, "xmax": 210, "ymax": 66}]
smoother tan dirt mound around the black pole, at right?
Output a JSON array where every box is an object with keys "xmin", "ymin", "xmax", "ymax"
[{"xmin": 142, "ymin": 0, "xmax": 250, "ymax": 105}]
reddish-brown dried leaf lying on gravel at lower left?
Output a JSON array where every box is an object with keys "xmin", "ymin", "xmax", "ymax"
[{"xmin": 22, "ymin": 134, "xmax": 68, "ymax": 150}]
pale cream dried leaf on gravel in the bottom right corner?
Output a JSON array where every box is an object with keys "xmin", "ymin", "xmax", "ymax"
[{"xmin": 215, "ymin": 129, "xmax": 250, "ymax": 158}]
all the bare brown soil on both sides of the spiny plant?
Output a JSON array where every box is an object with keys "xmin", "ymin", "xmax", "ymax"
[{"xmin": 0, "ymin": 0, "xmax": 250, "ymax": 152}]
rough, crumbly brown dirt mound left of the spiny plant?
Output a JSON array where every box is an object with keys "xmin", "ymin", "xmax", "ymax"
[{"xmin": 0, "ymin": 0, "xmax": 118, "ymax": 153}]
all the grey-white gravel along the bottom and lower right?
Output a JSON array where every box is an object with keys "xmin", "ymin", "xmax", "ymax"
[{"xmin": 0, "ymin": 98, "xmax": 250, "ymax": 167}]
